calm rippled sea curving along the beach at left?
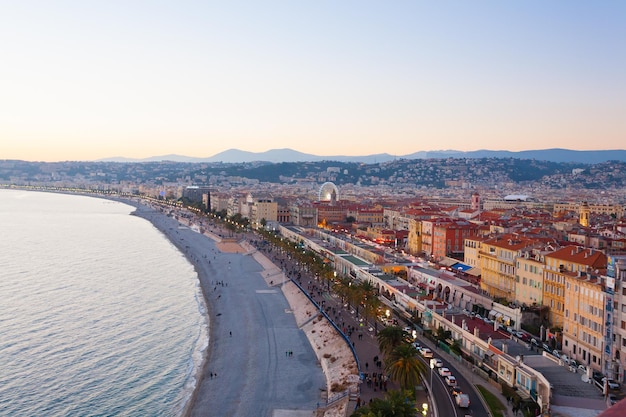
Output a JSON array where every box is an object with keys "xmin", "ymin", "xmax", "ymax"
[{"xmin": 0, "ymin": 190, "xmax": 208, "ymax": 417}]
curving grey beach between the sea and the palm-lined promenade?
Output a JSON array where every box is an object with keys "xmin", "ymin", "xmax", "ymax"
[{"xmin": 128, "ymin": 200, "xmax": 357, "ymax": 417}]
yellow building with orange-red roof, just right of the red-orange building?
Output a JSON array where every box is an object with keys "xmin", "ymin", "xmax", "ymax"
[{"xmin": 479, "ymin": 235, "xmax": 539, "ymax": 301}]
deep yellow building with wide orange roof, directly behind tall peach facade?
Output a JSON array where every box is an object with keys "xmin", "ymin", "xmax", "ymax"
[{"xmin": 543, "ymin": 246, "xmax": 606, "ymax": 328}]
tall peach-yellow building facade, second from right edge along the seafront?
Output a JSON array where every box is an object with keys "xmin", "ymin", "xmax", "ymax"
[{"xmin": 562, "ymin": 272, "xmax": 605, "ymax": 371}]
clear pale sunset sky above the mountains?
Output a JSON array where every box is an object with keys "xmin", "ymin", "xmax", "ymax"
[{"xmin": 0, "ymin": 0, "xmax": 626, "ymax": 161}]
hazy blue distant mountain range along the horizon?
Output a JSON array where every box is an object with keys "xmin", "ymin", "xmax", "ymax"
[{"xmin": 100, "ymin": 148, "xmax": 626, "ymax": 164}]
